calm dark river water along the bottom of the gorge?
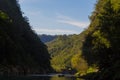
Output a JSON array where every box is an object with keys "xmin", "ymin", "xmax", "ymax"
[{"xmin": 0, "ymin": 75, "xmax": 84, "ymax": 80}]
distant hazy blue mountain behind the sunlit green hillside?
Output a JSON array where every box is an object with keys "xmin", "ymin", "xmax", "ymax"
[{"xmin": 39, "ymin": 34, "xmax": 58, "ymax": 43}]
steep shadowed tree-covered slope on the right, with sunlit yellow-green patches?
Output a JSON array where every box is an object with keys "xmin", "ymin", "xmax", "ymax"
[{"xmin": 83, "ymin": 0, "xmax": 120, "ymax": 80}]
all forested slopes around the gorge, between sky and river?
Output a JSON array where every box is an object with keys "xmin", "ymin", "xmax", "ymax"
[{"xmin": 0, "ymin": 0, "xmax": 120, "ymax": 80}]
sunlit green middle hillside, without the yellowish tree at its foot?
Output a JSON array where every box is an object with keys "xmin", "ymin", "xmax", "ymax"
[{"xmin": 47, "ymin": 32, "xmax": 87, "ymax": 71}]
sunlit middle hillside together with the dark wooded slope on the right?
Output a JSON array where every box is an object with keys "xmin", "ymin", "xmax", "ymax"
[{"xmin": 47, "ymin": 0, "xmax": 120, "ymax": 80}]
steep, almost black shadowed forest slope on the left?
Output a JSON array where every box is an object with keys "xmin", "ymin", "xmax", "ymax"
[{"xmin": 0, "ymin": 0, "xmax": 50, "ymax": 75}]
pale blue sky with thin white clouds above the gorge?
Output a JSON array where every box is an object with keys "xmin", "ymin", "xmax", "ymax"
[{"xmin": 19, "ymin": 0, "xmax": 96, "ymax": 35}]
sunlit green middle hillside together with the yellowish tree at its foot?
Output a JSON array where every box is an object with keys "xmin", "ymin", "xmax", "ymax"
[{"xmin": 47, "ymin": 32, "xmax": 93, "ymax": 75}]
